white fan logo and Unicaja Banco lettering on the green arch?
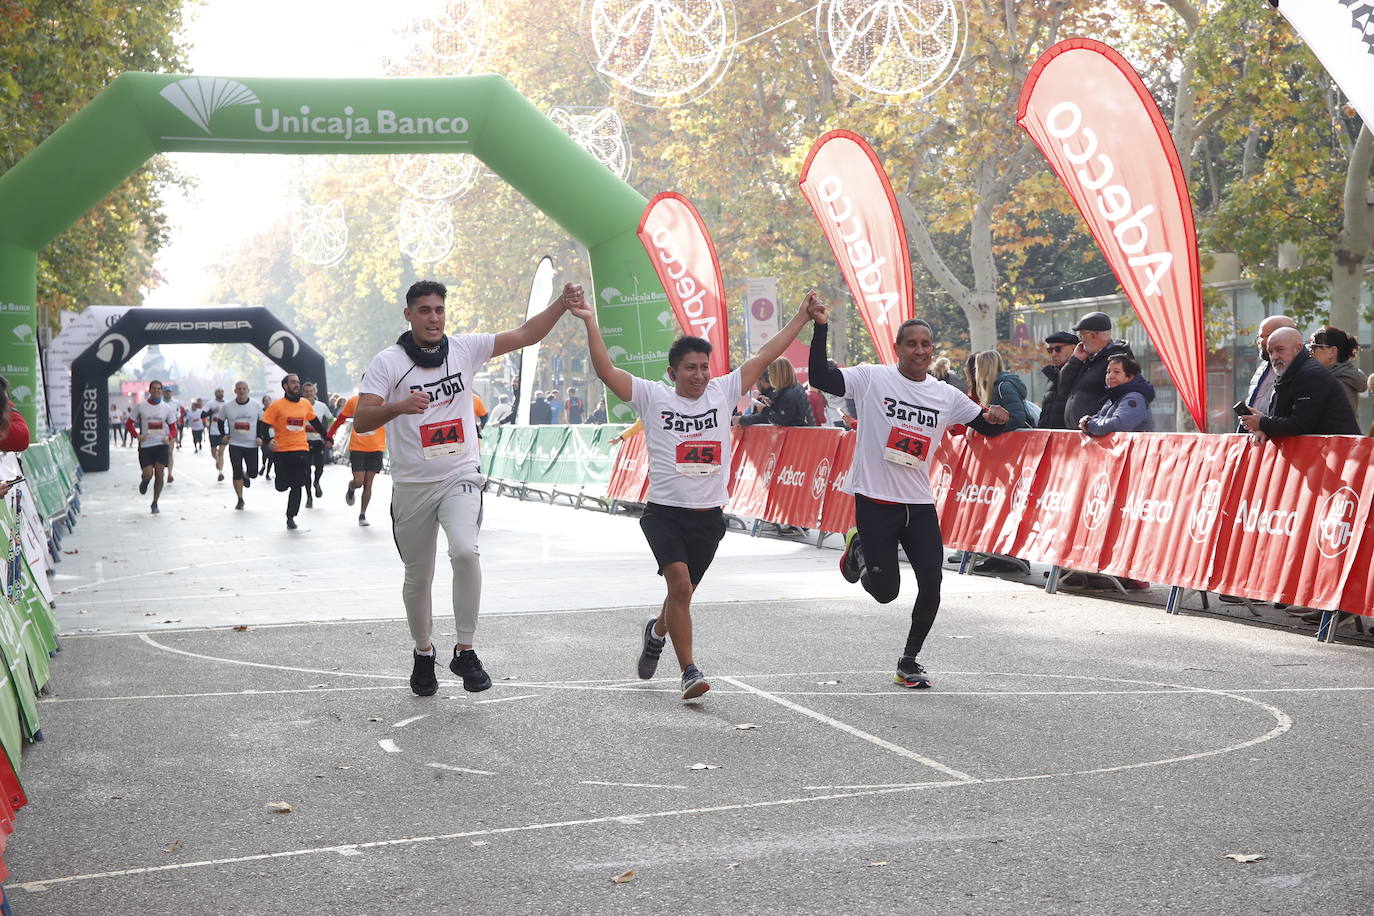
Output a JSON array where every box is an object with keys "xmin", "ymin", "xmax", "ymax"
[{"xmin": 161, "ymin": 77, "xmax": 469, "ymax": 140}]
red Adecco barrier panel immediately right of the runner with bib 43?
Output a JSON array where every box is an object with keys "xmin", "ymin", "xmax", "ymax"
[{"xmin": 932, "ymin": 430, "xmax": 1050, "ymax": 555}]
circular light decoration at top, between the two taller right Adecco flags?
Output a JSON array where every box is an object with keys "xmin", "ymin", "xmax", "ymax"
[{"xmin": 816, "ymin": 0, "xmax": 965, "ymax": 104}]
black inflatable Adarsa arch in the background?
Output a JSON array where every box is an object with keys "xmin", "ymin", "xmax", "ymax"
[{"xmin": 71, "ymin": 308, "xmax": 328, "ymax": 471}]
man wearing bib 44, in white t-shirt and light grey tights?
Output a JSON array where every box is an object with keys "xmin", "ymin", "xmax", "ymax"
[{"xmin": 353, "ymin": 280, "xmax": 583, "ymax": 696}]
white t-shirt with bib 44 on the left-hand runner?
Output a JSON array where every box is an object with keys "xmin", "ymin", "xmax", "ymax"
[{"xmin": 359, "ymin": 334, "xmax": 496, "ymax": 483}]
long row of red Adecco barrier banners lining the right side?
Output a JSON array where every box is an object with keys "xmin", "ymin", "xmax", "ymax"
[{"xmin": 611, "ymin": 427, "xmax": 1374, "ymax": 617}]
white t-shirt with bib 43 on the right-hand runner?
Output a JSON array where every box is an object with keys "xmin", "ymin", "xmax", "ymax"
[{"xmin": 840, "ymin": 365, "xmax": 982, "ymax": 505}]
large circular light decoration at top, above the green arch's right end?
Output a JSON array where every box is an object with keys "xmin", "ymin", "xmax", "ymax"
[{"xmin": 583, "ymin": 0, "xmax": 735, "ymax": 107}]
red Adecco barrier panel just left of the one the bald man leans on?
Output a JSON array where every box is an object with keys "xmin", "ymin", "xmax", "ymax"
[{"xmin": 1101, "ymin": 434, "xmax": 1250, "ymax": 589}]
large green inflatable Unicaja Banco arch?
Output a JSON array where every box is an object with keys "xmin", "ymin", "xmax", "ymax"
[{"xmin": 0, "ymin": 73, "xmax": 673, "ymax": 430}]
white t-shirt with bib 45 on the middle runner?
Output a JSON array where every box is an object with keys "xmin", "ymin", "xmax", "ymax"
[{"xmin": 629, "ymin": 369, "xmax": 741, "ymax": 509}]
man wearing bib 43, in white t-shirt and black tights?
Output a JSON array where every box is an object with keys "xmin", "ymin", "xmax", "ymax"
[{"xmin": 808, "ymin": 308, "xmax": 1007, "ymax": 687}]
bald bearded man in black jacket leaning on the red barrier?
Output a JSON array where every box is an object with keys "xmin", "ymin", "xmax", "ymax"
[{"xmin": 1241, "ymin": 328, "xmax": 1360, "ymax": 442}]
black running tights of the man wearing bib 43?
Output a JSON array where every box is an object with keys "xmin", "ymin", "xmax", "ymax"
[{"xmin": 855, "ymin": 496, "xmax": 944, "ymax": 655}]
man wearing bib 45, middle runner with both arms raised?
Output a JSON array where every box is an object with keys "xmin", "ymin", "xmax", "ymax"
[{"xmin": 573, "ymin": 293, "xmax": 823, "ymax": 700}]
